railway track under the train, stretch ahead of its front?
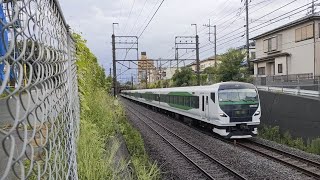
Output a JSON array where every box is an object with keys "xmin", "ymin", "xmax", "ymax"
[{"xmin": 234, "ymin": 140, "xmax": 320, "ymax": 180}]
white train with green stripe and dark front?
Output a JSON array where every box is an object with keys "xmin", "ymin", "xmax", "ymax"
[{"xmin": 120, "ymin": 82, "xmax": 261, "ymax": 139}]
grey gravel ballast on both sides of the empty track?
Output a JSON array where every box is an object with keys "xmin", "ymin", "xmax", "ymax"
[{"xmin": 122, "ymin": 99, "xmax": 311, "ymax": 179}]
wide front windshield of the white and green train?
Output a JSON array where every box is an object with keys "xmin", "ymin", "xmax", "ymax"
[{"xmin": 219, "ymin": 89, "xmax": 259, "ymax": 104}]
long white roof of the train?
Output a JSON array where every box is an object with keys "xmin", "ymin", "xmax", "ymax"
[{"xmin": 123, "ymin": 81, "xmax": 255, "ymax": 92}]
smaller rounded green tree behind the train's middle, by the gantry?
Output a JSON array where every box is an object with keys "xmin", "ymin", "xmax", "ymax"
[{"xmin": 172, "ymin": 67, "xmax": 193, "ymax": 87}]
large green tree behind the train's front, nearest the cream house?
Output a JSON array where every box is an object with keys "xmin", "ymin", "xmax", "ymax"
[{"xmin": 217, "ymin": 49, "xmax": 248, "ymax": 82}]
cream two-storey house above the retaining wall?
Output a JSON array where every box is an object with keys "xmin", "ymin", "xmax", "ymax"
[{"xmin": 252, "ymin": 15, "xmax": 320, "ymax": 77}]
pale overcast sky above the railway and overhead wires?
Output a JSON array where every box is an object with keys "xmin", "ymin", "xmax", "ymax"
[{"xmin": 59, "ymin": 0, "xmax": 320, "ymax": 82}]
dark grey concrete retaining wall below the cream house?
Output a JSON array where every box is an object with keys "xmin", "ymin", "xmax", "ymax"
[{"xmin": 259, "ymin": 91, "xmax": 320, "ymax": 140}]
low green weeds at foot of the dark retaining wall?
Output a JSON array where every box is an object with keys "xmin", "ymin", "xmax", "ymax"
[{"xmin": 259, "ymin": 126, "xmax": 320, "ymax": 155}]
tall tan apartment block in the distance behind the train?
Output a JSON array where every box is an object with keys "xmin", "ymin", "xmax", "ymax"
[{"xmin": 138, "ymin": 52, "xmax": 159, "ymax": 84}]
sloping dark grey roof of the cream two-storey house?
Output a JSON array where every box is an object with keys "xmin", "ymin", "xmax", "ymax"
[{"xmin": 251, "ymin": 15, "xmax": 320, "ymax": 40}]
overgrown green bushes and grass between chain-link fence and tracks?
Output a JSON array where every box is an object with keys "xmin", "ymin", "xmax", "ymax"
[{"xmin": 73, "ymin": 34, "xmax": 160, "ymax": 180}]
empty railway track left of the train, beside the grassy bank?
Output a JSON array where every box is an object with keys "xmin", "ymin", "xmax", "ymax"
[{"xmin": 126, "ymin": 104, "xmax": 246, "ymax": 179}]
